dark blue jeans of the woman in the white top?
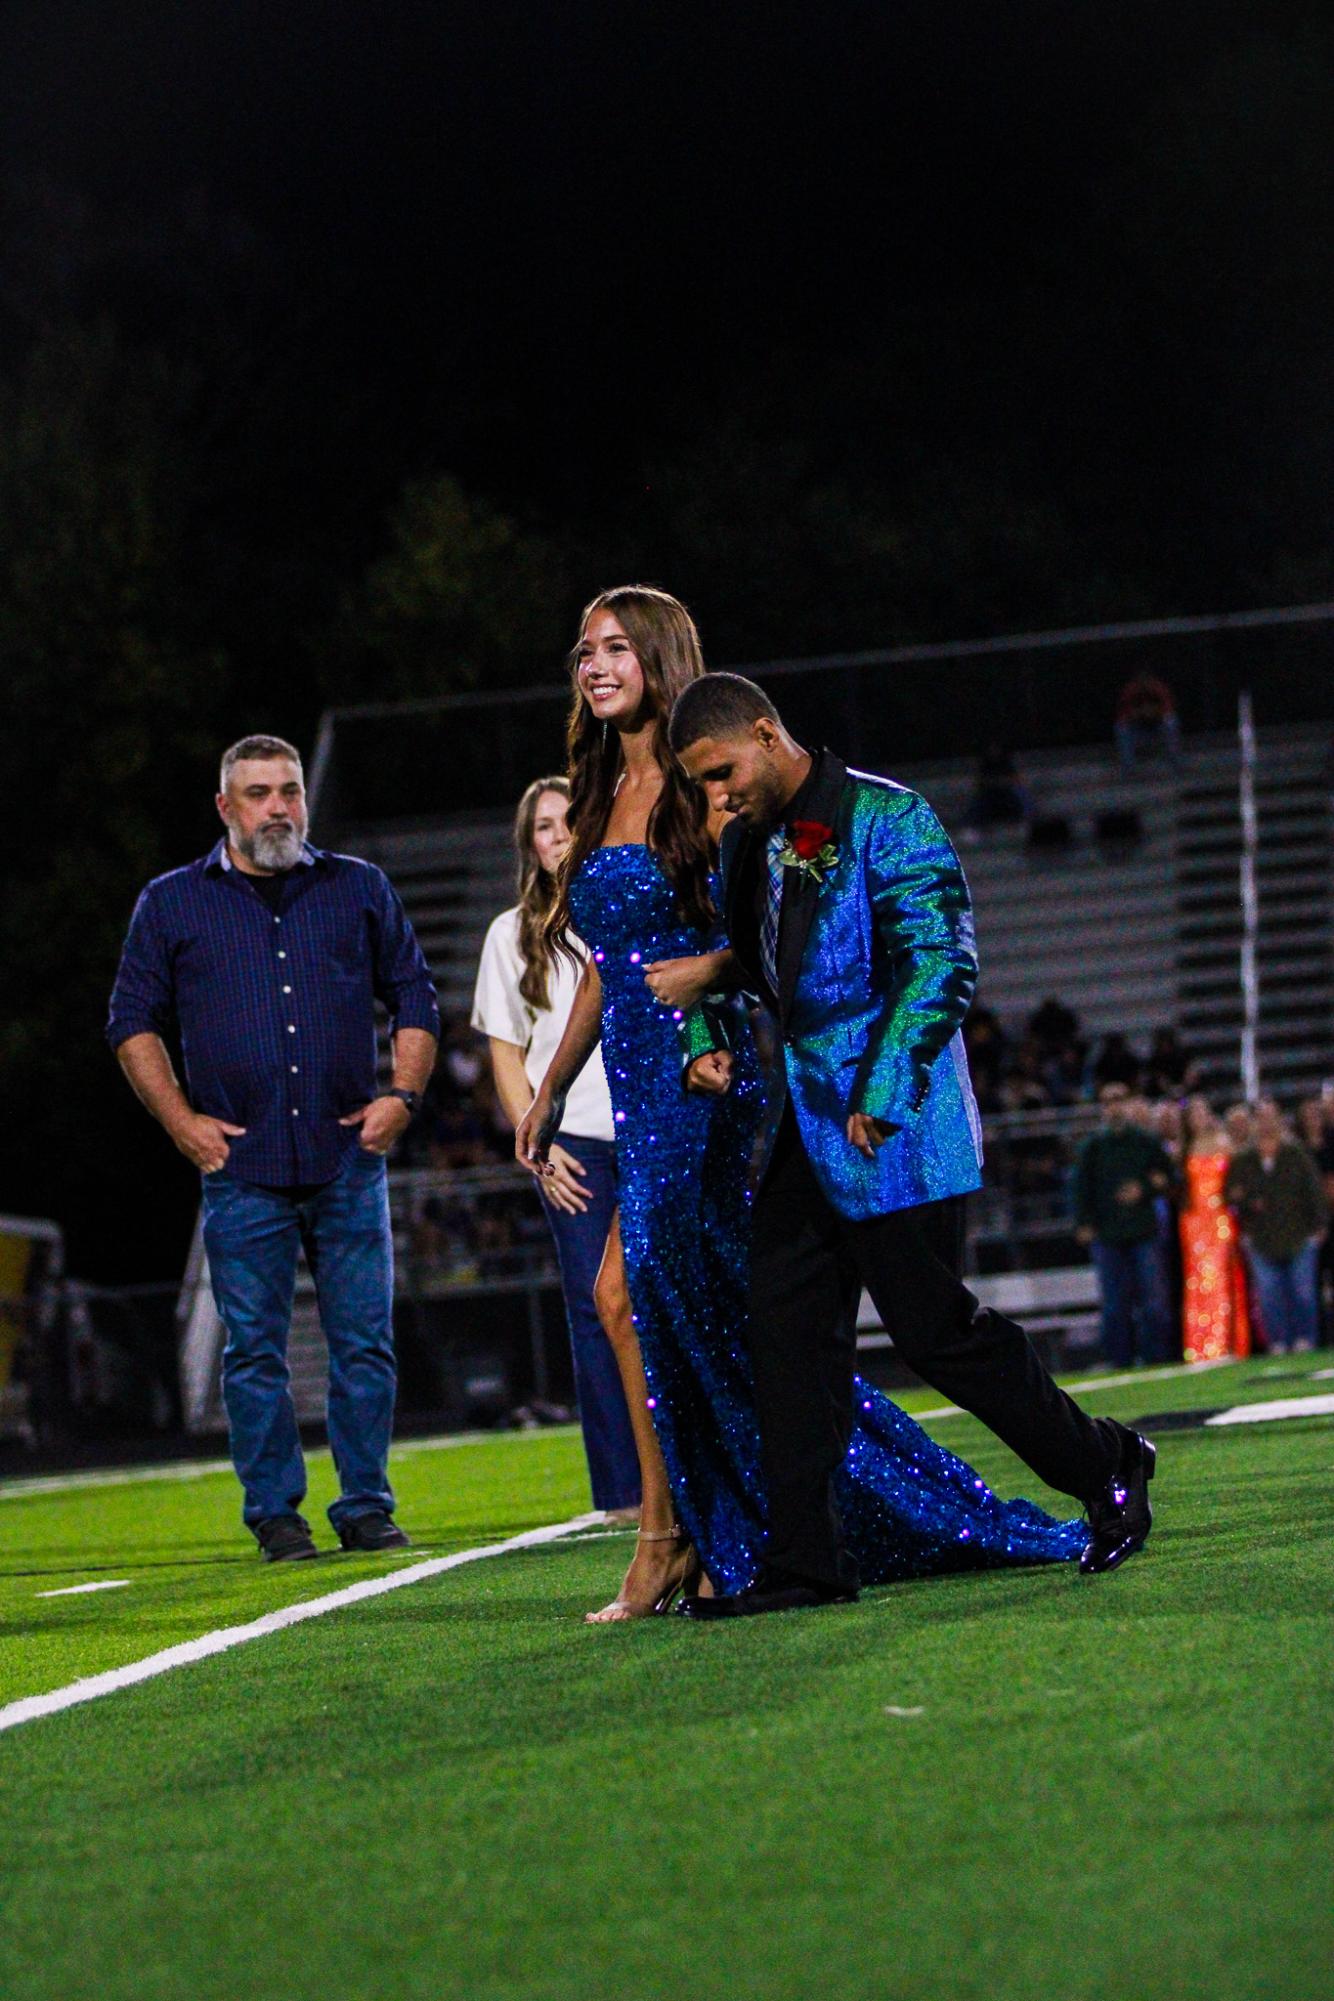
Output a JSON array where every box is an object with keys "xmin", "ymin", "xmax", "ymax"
[{"xmin": 542, "ymin": 1133, "xmax": 640, "ymax": 1509}]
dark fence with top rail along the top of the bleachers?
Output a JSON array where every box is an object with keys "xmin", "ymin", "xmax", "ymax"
[{"xmin": 308, "ymin": 602, "xmax": 1334, "ymax": 838}]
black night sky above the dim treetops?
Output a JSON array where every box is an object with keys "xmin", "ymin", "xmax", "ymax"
[{"xmin": 4, "ymin": 0, "xmax": 1332, "ymax": 616}]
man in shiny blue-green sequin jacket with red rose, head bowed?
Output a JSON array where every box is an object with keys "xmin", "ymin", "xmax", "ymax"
[{"xmin": 672, "ymin": 674, "xmax": 1154, "ymax": 1617}]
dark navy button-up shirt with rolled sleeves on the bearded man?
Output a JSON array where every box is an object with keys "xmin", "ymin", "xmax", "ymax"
[{"xmin": 106, "ymin": 840, "xmax": 440, "ymax": 1189}]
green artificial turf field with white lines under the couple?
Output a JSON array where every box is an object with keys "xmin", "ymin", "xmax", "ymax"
[{"xmin": 0, "ymin": 1359, "xmax": 1334, "ymax": 2001}]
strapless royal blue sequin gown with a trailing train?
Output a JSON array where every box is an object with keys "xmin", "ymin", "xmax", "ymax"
[{"xmin": 570, "ymin": 844, "xmax": 1088, "ymax": 1591}]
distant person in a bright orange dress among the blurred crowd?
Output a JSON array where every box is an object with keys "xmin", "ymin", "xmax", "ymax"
[{"xmin": 1180, "ymin": 1097, "xmax": 1250, "ymax": 1363}]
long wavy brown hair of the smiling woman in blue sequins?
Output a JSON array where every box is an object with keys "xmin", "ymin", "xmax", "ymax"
[{"xmin": 546, "ymin": 584, "xmax": 714, "ymax": 952}]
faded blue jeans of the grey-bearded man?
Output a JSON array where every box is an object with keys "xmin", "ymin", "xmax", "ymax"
[{"xmin": 204, "ymin": 1147, "xmax": 398, "ymax": 1529}]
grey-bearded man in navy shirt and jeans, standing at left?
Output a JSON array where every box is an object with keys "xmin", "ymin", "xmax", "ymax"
[{"xmin": 108, "ymin": 736, "xmax": 440, "ymax": 1559}]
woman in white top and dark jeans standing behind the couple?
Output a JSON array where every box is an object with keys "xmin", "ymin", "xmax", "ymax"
[{"xmin": 472, "ymin": 778, "xmax": 640, "ymax": 1515}]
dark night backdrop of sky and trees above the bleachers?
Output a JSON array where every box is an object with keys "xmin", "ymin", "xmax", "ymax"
[{"xmin": 0, "ymin": 0, "xmax": 1334, "ymax": 1275}]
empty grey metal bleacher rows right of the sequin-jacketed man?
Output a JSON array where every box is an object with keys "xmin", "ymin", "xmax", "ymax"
[{"xmin": 902, "ymin": 728, "xmax": 1334, "ymax": 1099}]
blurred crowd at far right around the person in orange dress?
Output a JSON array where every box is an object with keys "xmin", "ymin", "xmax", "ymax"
[{"xmin": 964, "ymin": 996, "xmax": 1334, "ymax": 1367}]
